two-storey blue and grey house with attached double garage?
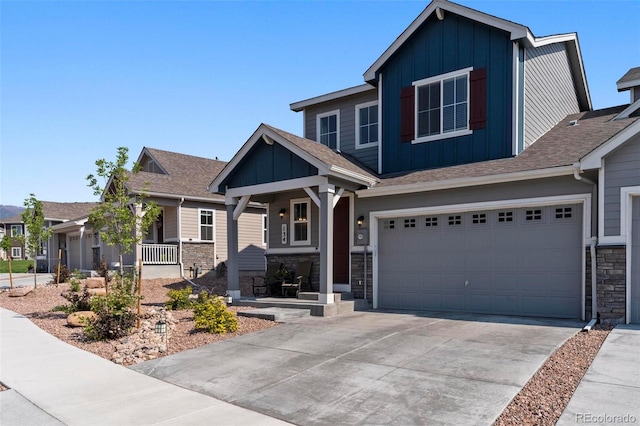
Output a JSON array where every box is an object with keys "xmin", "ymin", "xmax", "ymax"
[{"xmin": 210, "ymin": 0, "xmax": 640, "ymax": 323}]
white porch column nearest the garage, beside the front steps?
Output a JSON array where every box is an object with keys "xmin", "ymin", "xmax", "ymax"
[{"xmin": 318, "ymin": 184, "xmax": 336, "ymax": 303}]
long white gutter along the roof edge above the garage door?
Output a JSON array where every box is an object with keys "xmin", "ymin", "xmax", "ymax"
[{"xmin": 356, "ymin": 165, "xmax": 575, "ymax": 198}]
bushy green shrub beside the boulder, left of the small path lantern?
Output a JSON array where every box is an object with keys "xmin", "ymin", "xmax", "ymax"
[{"xmin": 84, "ymin": 277, "xmax": 139, "ymax": 340}]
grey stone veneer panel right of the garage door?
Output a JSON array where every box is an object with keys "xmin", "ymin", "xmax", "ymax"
[{"xmin": 596, "ymin": 246, "xmax": 627, "ymax": 322}]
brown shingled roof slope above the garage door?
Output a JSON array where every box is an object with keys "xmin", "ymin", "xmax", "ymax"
[{"xmin": 358, "ymin": 106, "xmax": 640, "ymax": 197}]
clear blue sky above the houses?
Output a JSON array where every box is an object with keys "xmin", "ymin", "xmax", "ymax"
[{"xmin": 0, "ymin": 0, "xmax": 640, "ymax": 205}]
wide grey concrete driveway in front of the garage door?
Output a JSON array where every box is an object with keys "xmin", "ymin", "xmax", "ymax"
[{"xmin": 132, "ymin": 311, "xmax": 583, "ymax": 425}]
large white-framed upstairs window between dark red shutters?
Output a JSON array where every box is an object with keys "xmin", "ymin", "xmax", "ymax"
[{"xmin": 413, "ymin": 68, "xmax": 471, "ymax": 142}]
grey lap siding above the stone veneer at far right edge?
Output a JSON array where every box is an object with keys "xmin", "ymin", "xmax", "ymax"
[{"xmin": 604, "ymin": 136, "xmax": 640, "ymax": 236}]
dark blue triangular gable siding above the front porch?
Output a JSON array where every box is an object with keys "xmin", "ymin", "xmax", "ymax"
[{"xmin": 220, "ymin": 139, "xmax": 318, "ymax": 192}]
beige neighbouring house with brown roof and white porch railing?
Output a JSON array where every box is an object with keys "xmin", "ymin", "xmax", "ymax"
[{"xmin": 54, "ymin": 148, "xmax": 266, "ymax": 278}]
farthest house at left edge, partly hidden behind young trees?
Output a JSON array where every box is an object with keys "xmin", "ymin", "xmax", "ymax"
[{"xmin": 3, "ymin": 201, "xmax": 95, "ymax": 272}]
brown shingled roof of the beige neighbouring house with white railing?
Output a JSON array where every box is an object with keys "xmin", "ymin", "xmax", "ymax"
[{"xmin": 127, "ymin": 147, "xmax": 227, "ymax": 201}]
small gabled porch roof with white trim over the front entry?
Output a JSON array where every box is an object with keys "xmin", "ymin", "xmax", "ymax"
[{"xmin": 209, "ymin": 123, "xmax": 377, "ymax": 192}]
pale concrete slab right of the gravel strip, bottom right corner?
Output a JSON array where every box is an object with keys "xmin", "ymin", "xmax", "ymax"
[{"xmin": 557, "ymin": 325, "xmax": 640, "ymax": 425}]
